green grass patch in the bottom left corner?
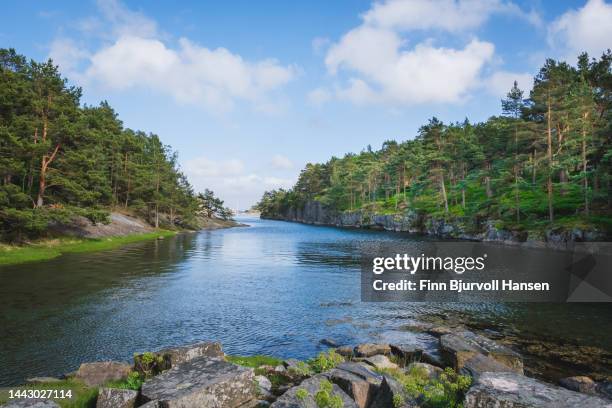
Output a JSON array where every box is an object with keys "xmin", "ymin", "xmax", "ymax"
[{"xmin": 0, "ymin": 379, "xmax": 98, "ymax": 408}]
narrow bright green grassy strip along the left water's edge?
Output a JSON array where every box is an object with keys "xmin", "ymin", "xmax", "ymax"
[{"xmin": 0, "ymin": 230, "xmax": 177, "ymax": 265}]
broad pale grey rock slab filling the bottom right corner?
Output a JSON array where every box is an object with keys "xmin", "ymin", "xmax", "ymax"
[{"xmin": 464, "ymin": 373, "xmax": 612, "ymax": 408}]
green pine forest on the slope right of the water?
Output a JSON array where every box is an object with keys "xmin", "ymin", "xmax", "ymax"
[{"xmin": 257, "ymin": 50, "xmax": 612, "ymax": 236}]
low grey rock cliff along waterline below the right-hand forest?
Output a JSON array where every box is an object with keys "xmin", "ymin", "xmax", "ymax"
[{"xmin": 262, "ymin": 201, "xmax": 609, "ymax": 249}]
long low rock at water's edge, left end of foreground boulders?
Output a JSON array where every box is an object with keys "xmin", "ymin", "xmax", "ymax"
[{"xmin": 134, "ymin": 342, "xmax": 225, "ymax": 374}]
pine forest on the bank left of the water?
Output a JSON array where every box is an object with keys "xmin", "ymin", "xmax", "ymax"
[{"xmin": 0, "ymin": 49, "xmax": 231, "ymax": 241}]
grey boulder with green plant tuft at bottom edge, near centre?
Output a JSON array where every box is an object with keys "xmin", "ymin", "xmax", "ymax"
[{"xmin": 270, "ymin": 374, "xmax": 357, "ymax": 408}]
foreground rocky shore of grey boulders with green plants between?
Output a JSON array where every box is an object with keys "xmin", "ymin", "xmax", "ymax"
[{"xmin": 6, "ymin": 325, "xmax": 612, "ymax": 408}]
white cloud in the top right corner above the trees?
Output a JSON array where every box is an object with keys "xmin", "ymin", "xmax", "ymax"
[{"xmin": 548, "ymin": 0, "xmax": 612, "ymax": 62}]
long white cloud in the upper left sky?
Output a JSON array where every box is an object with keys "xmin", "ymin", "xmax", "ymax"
[{"xmin": 50, "ymin": 0, "xmax": 297, "ymax": 112}]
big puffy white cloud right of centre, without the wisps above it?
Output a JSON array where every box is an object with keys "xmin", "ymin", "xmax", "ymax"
[{"xmin": 325, "ymin": 26, "xmax": 494, "ymax": 104}]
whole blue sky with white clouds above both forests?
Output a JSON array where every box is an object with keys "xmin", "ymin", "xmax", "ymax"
[{"xmin": 0, "ymin": 0, "xmax": 612, "ymax": 209}]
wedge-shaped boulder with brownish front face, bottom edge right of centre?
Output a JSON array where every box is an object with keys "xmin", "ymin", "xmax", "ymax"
[{"xmin": 326, "ymin": 363, "xmax": 382, "ymax": 408}]
